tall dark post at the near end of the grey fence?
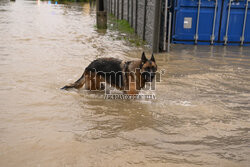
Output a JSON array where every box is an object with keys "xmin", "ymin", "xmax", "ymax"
[{"xmin": 152, "ymin": 1, "xmax": 161, "ymax": 53}]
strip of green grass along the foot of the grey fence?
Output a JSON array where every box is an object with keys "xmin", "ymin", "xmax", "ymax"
[{"xmin": 108, "ymin": 14, "xmax": 146, "ymax": 46}]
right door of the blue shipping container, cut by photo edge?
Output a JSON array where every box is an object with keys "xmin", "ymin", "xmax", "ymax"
[{"xmin": 220, "ymin": 0, "xmax": 250, "ymax": 45}]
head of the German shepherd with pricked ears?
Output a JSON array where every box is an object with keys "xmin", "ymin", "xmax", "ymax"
[{"xmin": 140, "ymin": 52, "xmax": 157, "ymax": 82}]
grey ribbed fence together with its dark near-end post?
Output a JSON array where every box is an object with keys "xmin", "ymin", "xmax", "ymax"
[{"xmin": 107, "ymin": 0, "xmax": 162, "ymax": 52}]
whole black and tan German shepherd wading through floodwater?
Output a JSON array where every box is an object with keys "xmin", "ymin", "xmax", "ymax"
[{"xmin": 61, "ymin": 52, "xmax": 157, "ymax": 95}]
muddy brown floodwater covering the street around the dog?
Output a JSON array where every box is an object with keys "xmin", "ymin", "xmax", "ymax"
[{"xmin": 0, "ymin": 0, "xmax": 250, "ymax": 167}]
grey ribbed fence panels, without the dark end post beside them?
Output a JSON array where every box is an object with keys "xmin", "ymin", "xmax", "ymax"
[{"xmin": 107, "ymin": 0, "xmax": 157, "ymax": 48}]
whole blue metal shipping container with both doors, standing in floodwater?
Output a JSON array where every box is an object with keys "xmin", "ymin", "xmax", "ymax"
[{"xmin": 172, "ymin": 0, "xmax": 250, "ymax": 45}]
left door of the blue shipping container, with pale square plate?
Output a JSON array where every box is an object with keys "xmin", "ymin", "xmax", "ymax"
[{"xmin": 172, "ymin": 0, "xmax": 222, "ymax": 44}]
